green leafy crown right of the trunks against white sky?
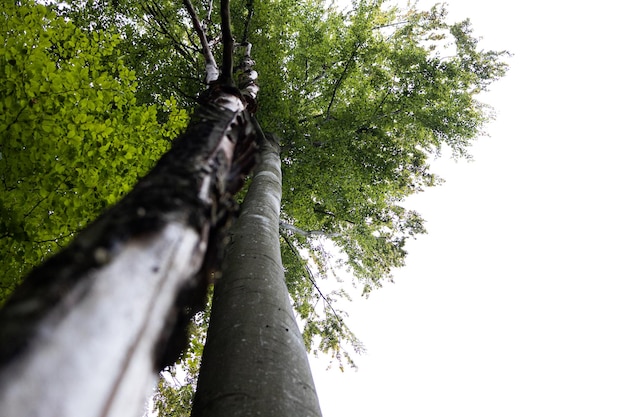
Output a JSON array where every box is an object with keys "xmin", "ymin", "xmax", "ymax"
[{"xmin": 239, "ymin": 0, "xmax": 507, "ymax": 293}]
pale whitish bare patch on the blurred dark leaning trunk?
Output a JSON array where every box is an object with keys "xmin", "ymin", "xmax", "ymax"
[{"xmin": 0, "ymin": 223, "xmax": 202, "ymax": 417}]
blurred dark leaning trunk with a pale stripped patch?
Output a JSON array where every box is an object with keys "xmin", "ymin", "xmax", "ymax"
[{"xmin": 0, "ymin": 85, "xmax": 257, "ymax": 417}]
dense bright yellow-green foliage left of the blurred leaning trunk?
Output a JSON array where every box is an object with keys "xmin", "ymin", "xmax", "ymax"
[{"xmin": 0, "ymin": 1, "xmax": 187, "ymax": 303}]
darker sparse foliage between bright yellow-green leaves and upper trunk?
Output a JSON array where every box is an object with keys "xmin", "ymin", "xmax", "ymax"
[{"xmin": 49, "ymin": 0, "xmax": 219, "ymax": 110}]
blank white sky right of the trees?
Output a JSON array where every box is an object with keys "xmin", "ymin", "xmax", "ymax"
[{"xmin": 312, "ymin": 0, "xmax": 626, "ymax": 417}]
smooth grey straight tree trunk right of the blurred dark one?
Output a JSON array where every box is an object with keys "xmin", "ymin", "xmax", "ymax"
[{"xmin": 191, "ymin": 132, "xmax": 321, "ymax": 417}]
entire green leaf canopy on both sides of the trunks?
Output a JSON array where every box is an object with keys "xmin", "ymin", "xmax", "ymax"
[{"xmin": 0, "ymin": 0, "xmax": 507, "ymax": 410}]
